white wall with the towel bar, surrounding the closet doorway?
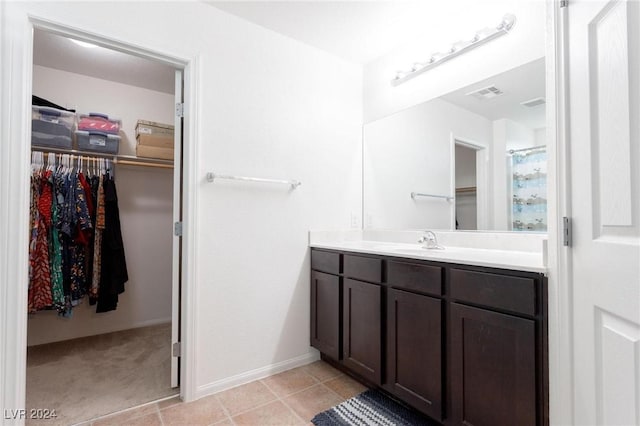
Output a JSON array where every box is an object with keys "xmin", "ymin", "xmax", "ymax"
[{"xmin": 0, "ymin": 2, "xmax": 362, "ymax": 406}]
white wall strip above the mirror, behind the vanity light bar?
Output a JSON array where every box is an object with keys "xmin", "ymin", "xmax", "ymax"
[{"xmin": 364, "ymin": 0, "xmax": 545, "ymax": 122}]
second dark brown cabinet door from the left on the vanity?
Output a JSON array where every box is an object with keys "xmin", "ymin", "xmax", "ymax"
[{"xmin": 343, "ymin": 279, "xmax": 382, "ymax": 385}]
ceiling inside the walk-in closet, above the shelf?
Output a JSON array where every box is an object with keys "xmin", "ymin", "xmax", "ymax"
[{"xmin": 33, "ymin": 30, "xmax": 175, "ymax": 95}]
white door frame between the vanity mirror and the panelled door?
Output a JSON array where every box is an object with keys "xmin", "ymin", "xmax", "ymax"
[{"xmin": 545, "ymin": 0, "xmax": 574, "ymax": 426}]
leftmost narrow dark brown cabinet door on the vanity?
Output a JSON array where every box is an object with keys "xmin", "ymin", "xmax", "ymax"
[{"xmin": 311, "ymin": 271, "xmax": 341, "ymax": 360}]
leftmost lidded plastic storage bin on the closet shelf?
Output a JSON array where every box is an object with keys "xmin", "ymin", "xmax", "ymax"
[{"xmin": 31, "ymin": 106, "xmax": 76, "ymax": 149}]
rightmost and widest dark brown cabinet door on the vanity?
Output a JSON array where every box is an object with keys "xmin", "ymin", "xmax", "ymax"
[{"xmin": 450, "ymin": 303, "xmax": 540, "ymax": 426}]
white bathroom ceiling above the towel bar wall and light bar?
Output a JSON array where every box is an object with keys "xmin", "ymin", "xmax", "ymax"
[{"xmin": 206, "ymin": 0, "xmax": 514, "ymax": 64}]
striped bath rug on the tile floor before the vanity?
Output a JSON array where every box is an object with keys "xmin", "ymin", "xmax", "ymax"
[{"xmin": 311, "ymin": 390, "xmax": 438, "ymax": 426}]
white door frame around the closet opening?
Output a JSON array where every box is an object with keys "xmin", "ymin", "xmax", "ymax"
[{"xmin": 0, "ymin": 15, "xmax": 201, "ymax": 418}]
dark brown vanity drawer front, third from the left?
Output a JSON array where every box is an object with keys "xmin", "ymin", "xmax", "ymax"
[{"xmin": 387, "ymin": 260, "xmax": 442, "ymax": 295}]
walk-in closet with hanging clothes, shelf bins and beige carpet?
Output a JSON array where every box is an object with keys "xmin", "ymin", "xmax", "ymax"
[{"xmin": 25, "ymin": 30, "xmax": 180, "ymax": 424}]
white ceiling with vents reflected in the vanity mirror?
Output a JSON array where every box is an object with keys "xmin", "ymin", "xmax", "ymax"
[{"xmin": 441, "ymin": 58, "xmax": 546, "ymax": 129}]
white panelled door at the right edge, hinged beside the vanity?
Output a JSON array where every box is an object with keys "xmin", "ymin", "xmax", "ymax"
[{"xmin": 567, "ymin": 0, "xmax": 640, "ymax": 425}]
